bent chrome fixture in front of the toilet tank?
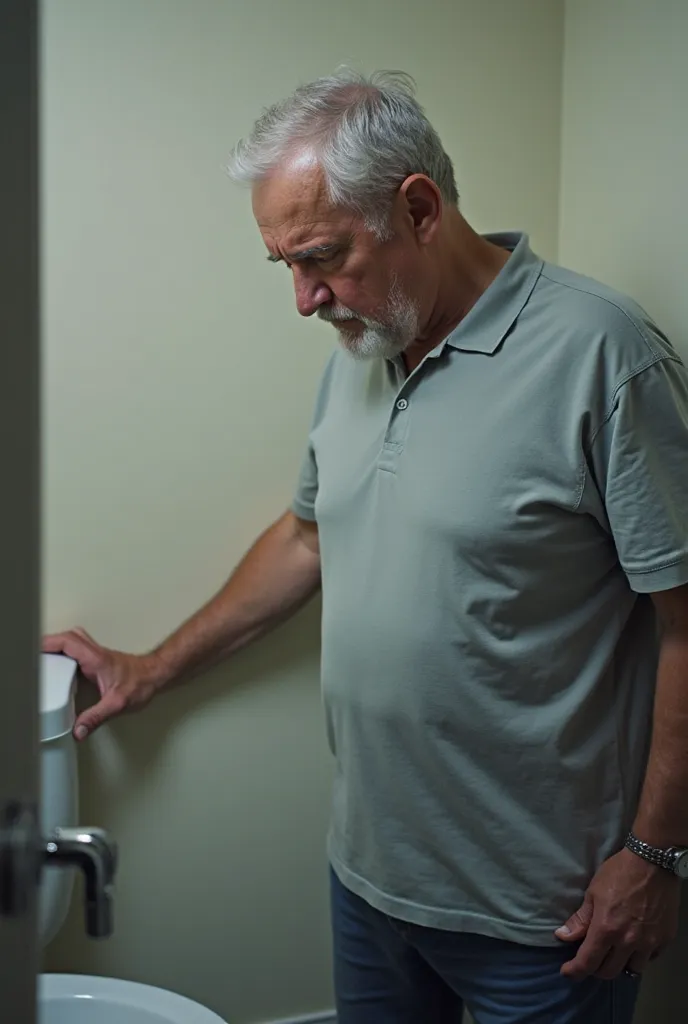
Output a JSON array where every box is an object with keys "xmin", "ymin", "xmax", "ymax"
[{"xmin": 43, "ymin": 828, "xmax": 117, "ymax": 938}]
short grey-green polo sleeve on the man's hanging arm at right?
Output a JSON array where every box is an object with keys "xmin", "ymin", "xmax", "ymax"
[{"xmin": 592, "ymin": 357, "xmax": 688, "ymax": 593}]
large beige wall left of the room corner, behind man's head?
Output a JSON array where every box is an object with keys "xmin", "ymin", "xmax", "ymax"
[{"xmin": 43, "ymin": 0, "xmax": 563, "ymax": 1024}]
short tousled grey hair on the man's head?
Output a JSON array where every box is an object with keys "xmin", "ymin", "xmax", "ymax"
[{"xmin": 228, "ymin": 68, "xmax": 459, "ymax": 234}]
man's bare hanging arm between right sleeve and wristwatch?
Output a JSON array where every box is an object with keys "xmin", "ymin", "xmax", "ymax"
[{"xmin": 633, "ymin": 589, "xmax": 688, "ymax": 847}]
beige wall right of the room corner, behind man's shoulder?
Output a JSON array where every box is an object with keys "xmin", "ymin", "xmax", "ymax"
[{"xmin": 559, "ymin": 0, "xmax": 688, "ymax": 1024}]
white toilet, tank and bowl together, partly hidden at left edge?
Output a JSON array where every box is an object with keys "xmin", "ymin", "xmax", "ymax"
[{"xmin": 38, "ymin": 654, "xmax": 226, "ymax": 1024}]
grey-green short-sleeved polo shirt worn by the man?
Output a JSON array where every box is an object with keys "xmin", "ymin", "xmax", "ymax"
[{"xmin": 294, "ymin": 234, "xmax": 688, "ymax": 944}]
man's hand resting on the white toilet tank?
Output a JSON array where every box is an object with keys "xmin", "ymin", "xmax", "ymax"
[{"xmin": 42, "ymin": 627, "xmax": 161, "ymax": 739}]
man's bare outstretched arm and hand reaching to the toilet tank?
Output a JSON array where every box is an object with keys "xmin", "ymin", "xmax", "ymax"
[{"xmin": 43, "ymin": 512, "xmax": 320, "ymax": 739}]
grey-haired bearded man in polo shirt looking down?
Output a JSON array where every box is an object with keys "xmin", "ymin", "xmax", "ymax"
[{"xmin": 45, "ymin": 72, "xmax": 688, "ymax": 1024}]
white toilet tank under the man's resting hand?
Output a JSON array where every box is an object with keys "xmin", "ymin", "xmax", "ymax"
[{"xmin": 39, "ymin": 654, "xmax": 79, "ymax": 945}]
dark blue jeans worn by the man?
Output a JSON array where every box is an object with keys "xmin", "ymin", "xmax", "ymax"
[{"xmin": 331, "ymin": 871, "xmax": 639, "ymax": 1024}]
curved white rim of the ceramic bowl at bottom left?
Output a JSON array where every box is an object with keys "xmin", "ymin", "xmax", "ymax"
[{"xmin": 38, "ymin": 974, "xmax": 226, "ymax": 1024}]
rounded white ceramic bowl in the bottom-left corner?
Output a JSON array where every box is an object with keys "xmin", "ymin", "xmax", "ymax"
[{"xmin": 38, "ymin": 974, "xmax": 226, "ymax": 1024}]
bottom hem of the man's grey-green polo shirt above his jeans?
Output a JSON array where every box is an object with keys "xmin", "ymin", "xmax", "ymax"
[{"xmin": 328, "ymin": 849, "xmax": 566, "ymax": 946}]
